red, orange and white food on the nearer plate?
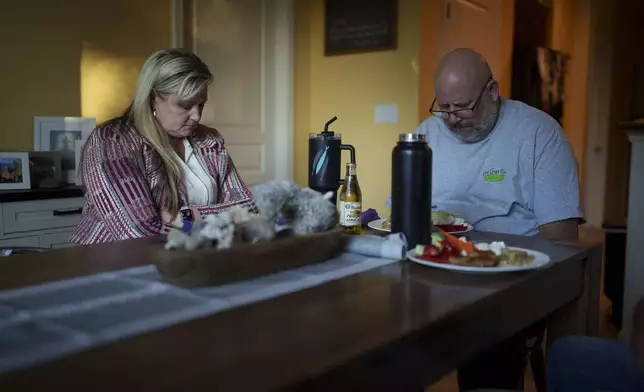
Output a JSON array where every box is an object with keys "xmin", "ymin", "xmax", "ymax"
[{"xmin": 415, "ymin": 234, "xmax": 534, "ymax": 268}]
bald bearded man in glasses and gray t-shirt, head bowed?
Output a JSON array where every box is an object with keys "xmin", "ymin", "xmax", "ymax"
[{"xmin": 390, "ymin": 49, "xmax": 583, "ymax": 390}]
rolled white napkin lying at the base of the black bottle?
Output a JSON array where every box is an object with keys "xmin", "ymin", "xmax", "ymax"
[{"xmin": 345, "ymin": 233, "xmax": 407, "ymax": 260}]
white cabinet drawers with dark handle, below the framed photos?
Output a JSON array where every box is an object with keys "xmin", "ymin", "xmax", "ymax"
[{"xmin": 0, "ymin": 197, "xmax": 85, "ymax": 249}]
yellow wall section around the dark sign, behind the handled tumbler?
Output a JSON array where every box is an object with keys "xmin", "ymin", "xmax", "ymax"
[{"xmin": 294, "ymin": 0, "xmax": 420, "ymax": 216}]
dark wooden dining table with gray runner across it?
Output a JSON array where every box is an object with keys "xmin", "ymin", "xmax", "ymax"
[{"xmin": 0, "ymin": 232, "xmax": 602, "ymax": 391}]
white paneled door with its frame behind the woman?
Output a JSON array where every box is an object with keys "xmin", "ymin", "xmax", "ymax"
[{"xmin": 172, "ymin": 0, "xmax": 293, "ymax": 186}]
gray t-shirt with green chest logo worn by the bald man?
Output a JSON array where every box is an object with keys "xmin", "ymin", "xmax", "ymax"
[{"xmin": 387, "ymin": 100, "xmax": 583, "ymax": 235}]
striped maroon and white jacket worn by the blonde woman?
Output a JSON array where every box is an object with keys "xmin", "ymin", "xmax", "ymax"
[{"xmin": 69, "ymin": 117, "xmax": 255, "ymax": 245}]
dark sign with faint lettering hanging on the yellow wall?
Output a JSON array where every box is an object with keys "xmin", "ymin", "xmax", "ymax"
[{"xmin": 324, "ymin": 0, "xmax": 398, "ymax": 56}]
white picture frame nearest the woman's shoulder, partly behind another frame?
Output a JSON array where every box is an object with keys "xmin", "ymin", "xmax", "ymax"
[{"xmin": 34, "ymin": 117, "xmax": 96, "ymax": 184}]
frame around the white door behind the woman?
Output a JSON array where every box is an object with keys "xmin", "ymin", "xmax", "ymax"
[{"xmin": 171, "ymin": 0, "xmax": 295, "ymax": 181}]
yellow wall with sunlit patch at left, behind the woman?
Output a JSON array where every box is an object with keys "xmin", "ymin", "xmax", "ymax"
[{"xmin": 0, "ymin": 0, "xmax": 172, "ymax": 151}]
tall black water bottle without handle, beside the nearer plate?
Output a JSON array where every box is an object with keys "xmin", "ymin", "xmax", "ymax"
[{"xmin": 391, "ymin": 133, "xmax": 432, "ymax": 249}]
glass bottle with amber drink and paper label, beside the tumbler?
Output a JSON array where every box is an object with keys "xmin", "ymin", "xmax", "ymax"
[{"xmin": 339, "ymin": 163, "xmax": 362, "ymax": 234}]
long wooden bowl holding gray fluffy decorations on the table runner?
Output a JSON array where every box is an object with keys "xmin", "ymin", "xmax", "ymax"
[{"xmin": 155, "ymin": 228, "xmax": 344, "ymax": 287}]
